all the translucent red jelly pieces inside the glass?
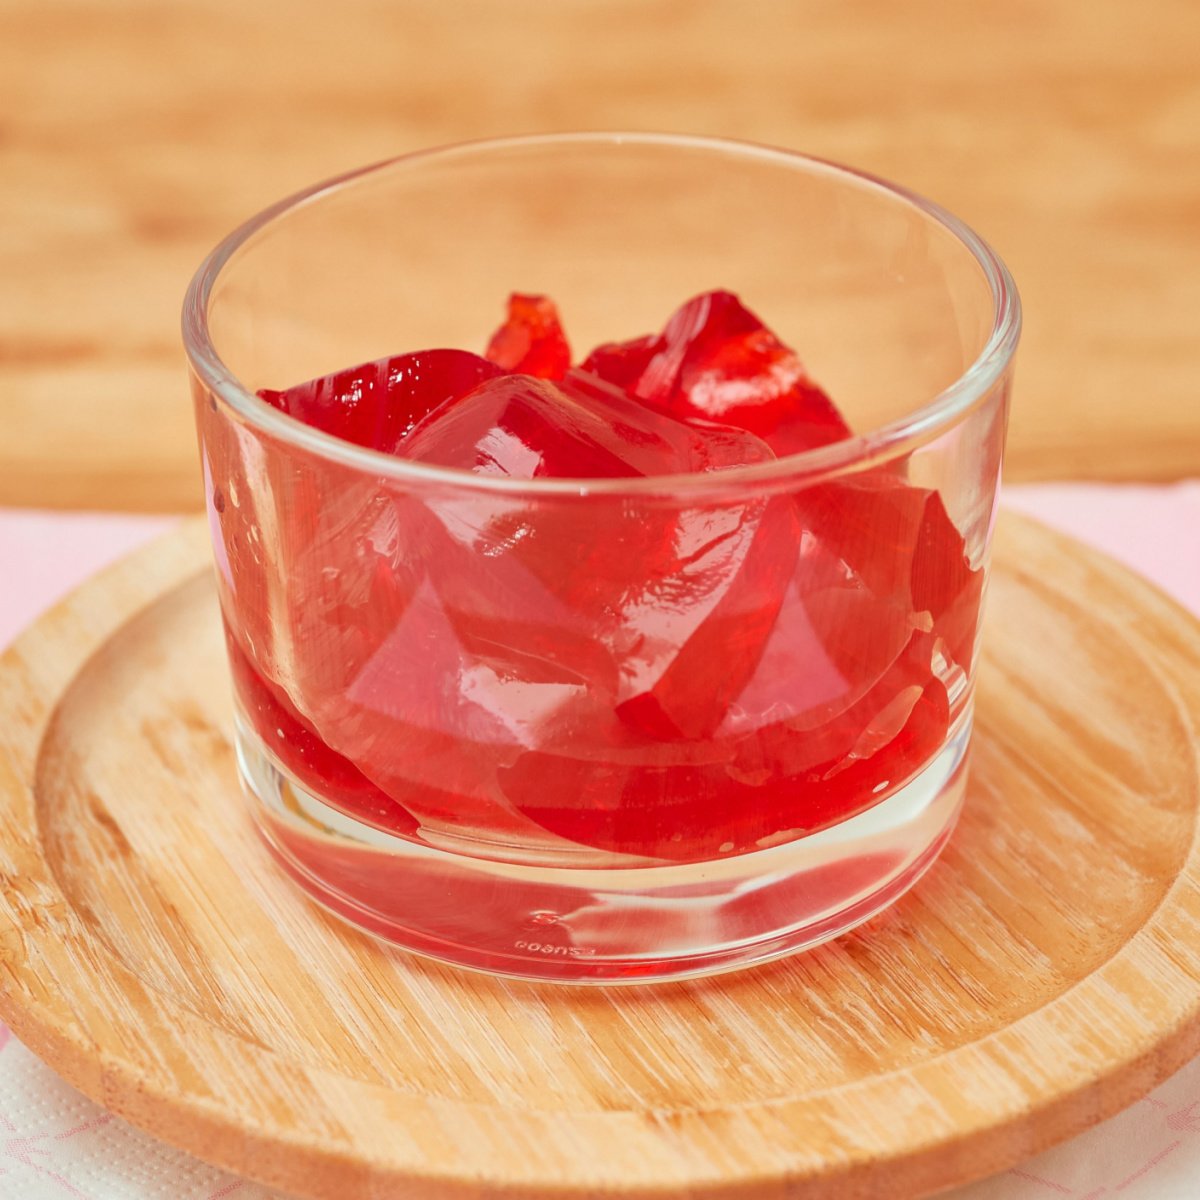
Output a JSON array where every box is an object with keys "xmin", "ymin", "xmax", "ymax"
[{"xmin": 205, "ymin": 292, "xmax": 983, "ymax": 862}]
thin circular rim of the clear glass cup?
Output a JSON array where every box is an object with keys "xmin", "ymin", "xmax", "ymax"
[{"xmin": 182, "ymin": 132, "xmax": 1021, "ymax": 497}]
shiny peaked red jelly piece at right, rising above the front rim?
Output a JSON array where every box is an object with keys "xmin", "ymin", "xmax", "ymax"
[{"xmin": 583, "ymin": 292, "xmax": 851, "ymax": 456}]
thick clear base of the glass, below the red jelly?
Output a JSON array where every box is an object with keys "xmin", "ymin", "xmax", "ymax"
[{"xmin": 238, "ymin": 708, "xmax": 971, "ymax": 984}]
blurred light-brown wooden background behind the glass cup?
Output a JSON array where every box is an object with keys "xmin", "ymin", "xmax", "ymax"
[{"xmin": 0, "ymin": 0, "xmax": 1200, "ymax": 510}]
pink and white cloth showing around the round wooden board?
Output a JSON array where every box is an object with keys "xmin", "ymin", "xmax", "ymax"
[{"xmin": 0, "ymin": 482, "xmax": 1200, "ymax": 1200}]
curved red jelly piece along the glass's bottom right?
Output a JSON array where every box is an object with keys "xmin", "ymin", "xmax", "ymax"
[{"xmin": 503, "ymin": 634, "xmax": 949, "ymax": 862}]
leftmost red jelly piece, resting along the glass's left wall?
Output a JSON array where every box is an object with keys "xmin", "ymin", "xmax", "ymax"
[{"xmin": 198, "ymin": 350, "xmax": 516, "ymax": 832}]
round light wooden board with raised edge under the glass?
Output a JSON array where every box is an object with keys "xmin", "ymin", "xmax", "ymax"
[{"xmin": 0, "ymin": 517, "xmax": 1200, "ymax": 1200}]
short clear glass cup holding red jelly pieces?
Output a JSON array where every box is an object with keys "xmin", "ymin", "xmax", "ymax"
[{"xmin": 184, "ymin": 134, "xmax": 1020, "ymax": 982}]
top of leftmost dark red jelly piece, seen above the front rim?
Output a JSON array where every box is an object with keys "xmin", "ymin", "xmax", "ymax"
[{"xmin": 258, "ymin": 350, "xmax": 500, "ymax": 454}]
